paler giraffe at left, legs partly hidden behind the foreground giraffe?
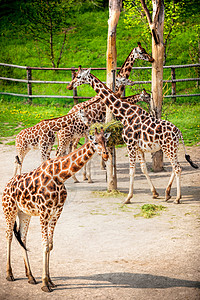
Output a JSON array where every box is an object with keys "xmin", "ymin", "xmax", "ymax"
[{"xmin": 14, "ymin": 109, "xmax": 88, "ymax": 175}]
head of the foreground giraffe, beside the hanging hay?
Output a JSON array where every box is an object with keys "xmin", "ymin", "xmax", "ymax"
[{"xmin": 89, "ymin": 128, "xmax": 110, "ymax": 161}]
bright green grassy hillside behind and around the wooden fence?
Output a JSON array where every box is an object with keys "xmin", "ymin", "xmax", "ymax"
[{"xmin": 0, "ymin": 2, "xmax": 200, "ymax": 144}]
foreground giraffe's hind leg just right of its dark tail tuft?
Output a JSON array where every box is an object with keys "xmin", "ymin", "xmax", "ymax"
[{"xmin": 18, "ymin": 211, "xmax": 36, "ymax": 284}]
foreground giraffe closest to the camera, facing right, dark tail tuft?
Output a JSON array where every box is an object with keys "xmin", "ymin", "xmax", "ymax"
[{"xmin": 2, "ymin": 129, "xmax": 110, "ymax": 292}]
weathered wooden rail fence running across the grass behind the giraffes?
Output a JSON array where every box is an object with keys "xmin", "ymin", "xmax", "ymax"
[{"xmin": 0, "ymin": 63, "xmax": 200, "ymax": 104}]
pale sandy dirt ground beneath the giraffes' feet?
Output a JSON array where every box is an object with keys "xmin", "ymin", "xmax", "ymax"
[{"xmin": 0, "ymin": 144, "xmax": 200, "ymax": 300}]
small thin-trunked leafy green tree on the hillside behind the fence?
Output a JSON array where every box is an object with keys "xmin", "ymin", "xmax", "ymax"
[{"xmin": 22, "ymin": 0, "xmax": 74, "ymax": 68}]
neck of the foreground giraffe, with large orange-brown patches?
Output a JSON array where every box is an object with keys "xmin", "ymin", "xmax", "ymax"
[{"xmin": 51, "ymin": 141, "xmax": 96, "ymax": 184}]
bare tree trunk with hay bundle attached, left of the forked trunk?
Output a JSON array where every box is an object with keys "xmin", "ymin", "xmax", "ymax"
[{"xmin": 106, "ymin": 0, "xmax": 122, "ymax": 191}]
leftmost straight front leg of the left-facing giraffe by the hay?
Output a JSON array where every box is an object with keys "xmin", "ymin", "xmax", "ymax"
[{"xmin": 123, "ymin": 147, "xmax": 136, "ymax": 204}]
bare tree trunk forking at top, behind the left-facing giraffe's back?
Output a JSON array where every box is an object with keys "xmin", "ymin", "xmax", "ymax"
[{"xmin": 151, "ymin": 0, "xmax": 164, "ymax": 172}]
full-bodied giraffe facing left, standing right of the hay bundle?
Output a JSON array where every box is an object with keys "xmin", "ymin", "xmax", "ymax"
[{"xmin": 66, "ymin": 68, "xmax": 198, "ymax": 203}]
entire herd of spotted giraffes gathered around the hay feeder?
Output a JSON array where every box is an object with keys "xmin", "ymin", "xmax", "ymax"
[{"xmin": 2, "ymin": 43, "xmax": 198, "ymax": 292}]
